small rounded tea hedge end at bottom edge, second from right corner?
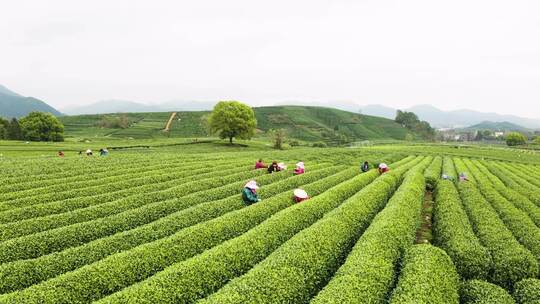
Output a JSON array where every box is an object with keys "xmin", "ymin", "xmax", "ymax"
[{"xmin": 460, "ymin": 280, "xmax": 515, "ymax": 304}]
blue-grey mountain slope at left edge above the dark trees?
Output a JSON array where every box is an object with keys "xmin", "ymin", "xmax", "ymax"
[{"xmin": 0, "ymin": 85, "xmax": 62, "ymax": 118}]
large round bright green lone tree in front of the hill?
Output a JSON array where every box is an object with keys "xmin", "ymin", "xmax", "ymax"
[{"xmin": 208, "ymin": 101, "xmax": 257, "ymax": 144}]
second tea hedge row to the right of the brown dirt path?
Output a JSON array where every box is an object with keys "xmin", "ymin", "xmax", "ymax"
[{"xmin": 458, "ymin": 182, "xmax": 538, "ymax": 288}]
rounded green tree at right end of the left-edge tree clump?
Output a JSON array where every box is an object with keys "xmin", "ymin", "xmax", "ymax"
[{"xmin": 19, "ymin": 112, "xmax": 64, "ymax": 141}]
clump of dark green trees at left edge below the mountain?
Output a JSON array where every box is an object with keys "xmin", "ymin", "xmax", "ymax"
[{"xmin": 0, "ymin": 112, "xmax": 64, "ymax": 141}]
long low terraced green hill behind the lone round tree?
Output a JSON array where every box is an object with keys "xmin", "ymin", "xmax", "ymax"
[{"xmin": 61, "ymin": 106, "xmax": 410, "ymax": 142}]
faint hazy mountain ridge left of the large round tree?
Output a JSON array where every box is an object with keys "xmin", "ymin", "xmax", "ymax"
[{"xmin": 63, "ymin": 99, "xmax": 214, "ymax": 115}]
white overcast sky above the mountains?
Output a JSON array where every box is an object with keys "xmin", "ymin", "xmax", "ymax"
[{"xmin": 0, "ymin": 0, "xmax": 540, "ymax": 117}]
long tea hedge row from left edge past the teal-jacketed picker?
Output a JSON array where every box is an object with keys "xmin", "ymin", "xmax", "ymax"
[{"xmin": 0, "ymin": 166, "xmax": 341, "ymax": 293}]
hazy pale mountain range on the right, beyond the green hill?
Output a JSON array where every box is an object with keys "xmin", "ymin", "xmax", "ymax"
[{"xmin": 362, "ymin": 105, "xmax": 540, "ymax": 129}]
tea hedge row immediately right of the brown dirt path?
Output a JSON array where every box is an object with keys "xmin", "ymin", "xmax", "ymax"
[{"xmin": 433, "ymin": 180, "xmax": 492, "ymax": 279}]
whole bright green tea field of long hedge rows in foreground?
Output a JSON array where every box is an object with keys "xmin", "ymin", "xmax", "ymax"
[{"xmin": 0, "ymin": 149, "xmax": 540, "ymax": 304}]
